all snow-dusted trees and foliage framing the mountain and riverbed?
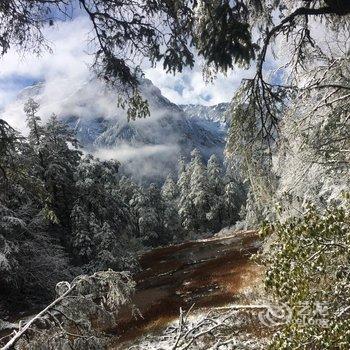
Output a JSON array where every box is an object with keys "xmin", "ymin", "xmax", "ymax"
[{"xmin": 0, "ymin": 0, "xmax": 350, "ymax": 350}]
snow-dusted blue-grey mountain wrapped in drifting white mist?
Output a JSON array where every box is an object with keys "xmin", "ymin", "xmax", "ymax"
[{"xmin": 4, "ymin": 80, "xmax": 232, "ymax": 182}]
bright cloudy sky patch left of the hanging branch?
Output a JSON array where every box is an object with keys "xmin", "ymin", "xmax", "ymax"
[{"xmin": 0, "ymin": 17, "xmax": 91, "ymax": 113}]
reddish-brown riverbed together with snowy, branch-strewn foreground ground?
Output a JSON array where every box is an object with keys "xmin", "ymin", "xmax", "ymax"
[{"xmin": 1, "ymin": 230, "xmax": 273, "ymax": 350}]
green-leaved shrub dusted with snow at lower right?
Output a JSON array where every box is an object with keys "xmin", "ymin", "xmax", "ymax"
[{"xmin": 262, "ymin": 196, "xmax": 350, "ymax": 350}]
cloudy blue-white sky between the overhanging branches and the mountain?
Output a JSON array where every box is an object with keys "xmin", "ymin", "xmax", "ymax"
[{"xmin": 0, "ymin": 17, "xmax": 253, "ymax": 115}]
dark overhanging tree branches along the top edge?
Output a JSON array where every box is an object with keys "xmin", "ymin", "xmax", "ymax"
[{"xmin": 0, "ymin": 0, "xmax": 350, "ymax": 121}]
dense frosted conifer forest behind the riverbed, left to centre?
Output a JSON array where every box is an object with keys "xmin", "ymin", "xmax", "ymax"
[{"xmin": 0, "ymin": 100, "xmax": 245, "ymax": 311}]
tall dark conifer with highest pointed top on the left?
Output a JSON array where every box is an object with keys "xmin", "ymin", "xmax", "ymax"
[{"xmin": 24, "ymin": 105, "xmax": 81, "ymax": 228}]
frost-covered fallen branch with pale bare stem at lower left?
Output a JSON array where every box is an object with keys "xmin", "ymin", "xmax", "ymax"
[{"xmin": 2, "ymin": 270, "xmax": 134, "ymax": 350}]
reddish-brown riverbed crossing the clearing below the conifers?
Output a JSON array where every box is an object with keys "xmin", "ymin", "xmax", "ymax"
[{"xmin": 113, "ymin": 231, "xmax": 261, "ymax": 349}]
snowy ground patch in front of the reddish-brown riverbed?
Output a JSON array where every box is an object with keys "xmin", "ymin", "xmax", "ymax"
[{"xmin": 118, "ymin": 300, "xmax": 269, "ymax": 350}]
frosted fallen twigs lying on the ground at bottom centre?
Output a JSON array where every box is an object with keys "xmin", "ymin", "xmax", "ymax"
[{"xmin": 129, "ymin": 305, "xmax": 268, "ymax": 350}]
